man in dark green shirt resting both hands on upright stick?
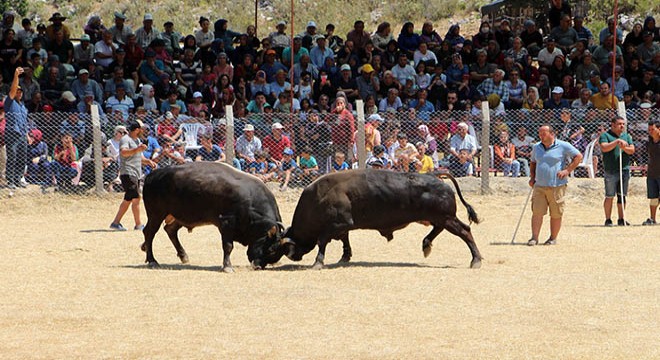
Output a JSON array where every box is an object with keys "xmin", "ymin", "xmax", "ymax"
[{"xmin": 598, "ymin": 116, "xmax": 635, "ymax": 226}]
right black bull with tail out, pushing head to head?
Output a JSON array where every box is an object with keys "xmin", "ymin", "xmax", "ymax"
[{"xmin": 257, "ymin": 170, "xmax": 482, "ymax": 268}]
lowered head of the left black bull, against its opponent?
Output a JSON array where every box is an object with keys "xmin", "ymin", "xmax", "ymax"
[{"xmin": 248, "ymin": 223, "xmax": 295, "ymax": 269}]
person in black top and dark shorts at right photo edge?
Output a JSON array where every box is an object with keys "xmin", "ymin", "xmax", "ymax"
[{"xmin": 642, "ymin": 120, "xmax": 660, "ymax": 225}]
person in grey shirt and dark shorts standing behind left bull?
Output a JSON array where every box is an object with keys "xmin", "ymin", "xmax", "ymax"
[{"xmin": 110, "ymin": 120, "xmax": 157, "ymax": 231}]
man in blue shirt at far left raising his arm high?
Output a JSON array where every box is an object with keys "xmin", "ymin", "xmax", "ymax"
[{"xmin": 5, "ymin": 66, "xmax": 28, "ymax": 194}]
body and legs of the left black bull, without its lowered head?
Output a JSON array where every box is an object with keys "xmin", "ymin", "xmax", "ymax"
[{"xmin": 142, "ymin": 162, "xmax": 283, "ymax": 272}]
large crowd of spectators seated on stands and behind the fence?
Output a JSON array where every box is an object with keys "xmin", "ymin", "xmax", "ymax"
[{"xmin": 0, "ymin": 7, "xmax": 660, "ymax": 189}]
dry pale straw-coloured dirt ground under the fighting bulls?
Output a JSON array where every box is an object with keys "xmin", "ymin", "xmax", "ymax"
[{"xmin": 0, "ymin": 178, "xmax": 660, "ymax": 359}]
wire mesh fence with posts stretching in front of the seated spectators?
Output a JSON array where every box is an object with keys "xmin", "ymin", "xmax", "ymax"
[{"xmin": 0, "ymin": 101, "xmax": 660, "ymax": 196}]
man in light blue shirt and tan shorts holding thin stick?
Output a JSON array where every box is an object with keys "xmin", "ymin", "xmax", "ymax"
[{"xmin": 527, "ymin": 124, "xmax": 582, "ymax": 246}]
